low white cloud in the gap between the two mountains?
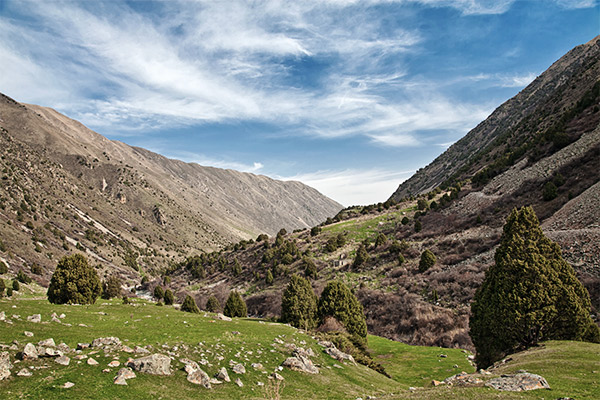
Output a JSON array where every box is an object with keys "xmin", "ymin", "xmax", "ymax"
[{"xmin": 277, "ymin": 169, "xmax": 414, "ymax": 206}]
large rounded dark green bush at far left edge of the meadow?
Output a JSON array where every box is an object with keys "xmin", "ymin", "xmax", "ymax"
[{"xmin": 47, "ymin": 254, "xmax": 102, "ymax": 304}]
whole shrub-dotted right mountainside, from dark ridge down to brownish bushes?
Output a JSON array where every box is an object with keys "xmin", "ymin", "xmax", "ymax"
[{"xmin": 157, "ymin": 37, "xmax": 600, "ymax": 348}]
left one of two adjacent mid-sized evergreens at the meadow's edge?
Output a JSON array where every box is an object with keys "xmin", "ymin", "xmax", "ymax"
[{"xmin": 281, "ymin": 275, "xmax": 317, "ymax": 330}]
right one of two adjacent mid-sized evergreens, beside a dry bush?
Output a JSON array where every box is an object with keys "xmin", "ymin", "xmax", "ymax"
[{"xmin": 317, "ymin": 281, "xmax": 367, "ymax": 340}]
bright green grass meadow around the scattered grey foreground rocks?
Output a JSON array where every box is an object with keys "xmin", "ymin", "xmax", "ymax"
[{"xmin": 0, "ymin": 296, "xmax": 600, "ymax": 400}]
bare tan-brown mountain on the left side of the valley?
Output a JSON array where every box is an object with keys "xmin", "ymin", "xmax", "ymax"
[{"xmin": 0, "ymin": 95, "xmax": 342, "ymax": 278}]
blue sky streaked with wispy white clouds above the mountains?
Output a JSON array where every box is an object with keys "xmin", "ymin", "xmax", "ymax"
[{"xmin": 0, "ymin": 0, "xmax": 600, "ymax": 205}]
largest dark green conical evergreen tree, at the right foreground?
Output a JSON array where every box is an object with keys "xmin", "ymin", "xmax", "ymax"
[{"xmin": 469, "ymin": 207, "xmax": 600, "ymax": 367}]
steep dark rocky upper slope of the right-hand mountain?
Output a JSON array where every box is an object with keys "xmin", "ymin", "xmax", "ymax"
[{"xmin": 391, "ymin": 36, "xmax": 600, "ymax": 200}]
